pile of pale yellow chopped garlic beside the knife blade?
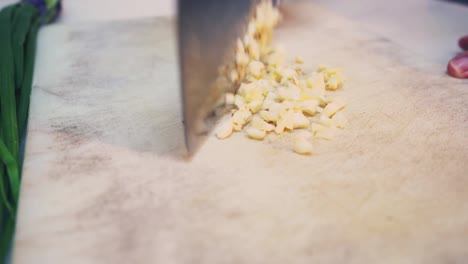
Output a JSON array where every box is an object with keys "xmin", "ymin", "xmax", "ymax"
[{"xmin": 216, "ymin": 1, "xmax": 347, "ymax": 154}]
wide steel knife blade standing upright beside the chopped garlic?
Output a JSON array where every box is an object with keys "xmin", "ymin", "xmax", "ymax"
[{"xmin": 178, "ymin": 0, "xmax": 256, "ymax": 154}]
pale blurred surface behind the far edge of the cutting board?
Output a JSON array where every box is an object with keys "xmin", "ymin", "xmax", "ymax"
[{"xmin": 0, "ymin": 0, "xmax": 468, "ymax": 63}]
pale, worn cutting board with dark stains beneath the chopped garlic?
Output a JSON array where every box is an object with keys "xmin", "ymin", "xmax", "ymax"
[{"xmin": 14, "ymin": 4, "xmax": 468, "ymax": 264}]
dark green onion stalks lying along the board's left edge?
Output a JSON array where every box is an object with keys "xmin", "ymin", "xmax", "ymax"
[{"xmin": 0, "ymin": 0, "xmax": 61, "ymax": 263}]
